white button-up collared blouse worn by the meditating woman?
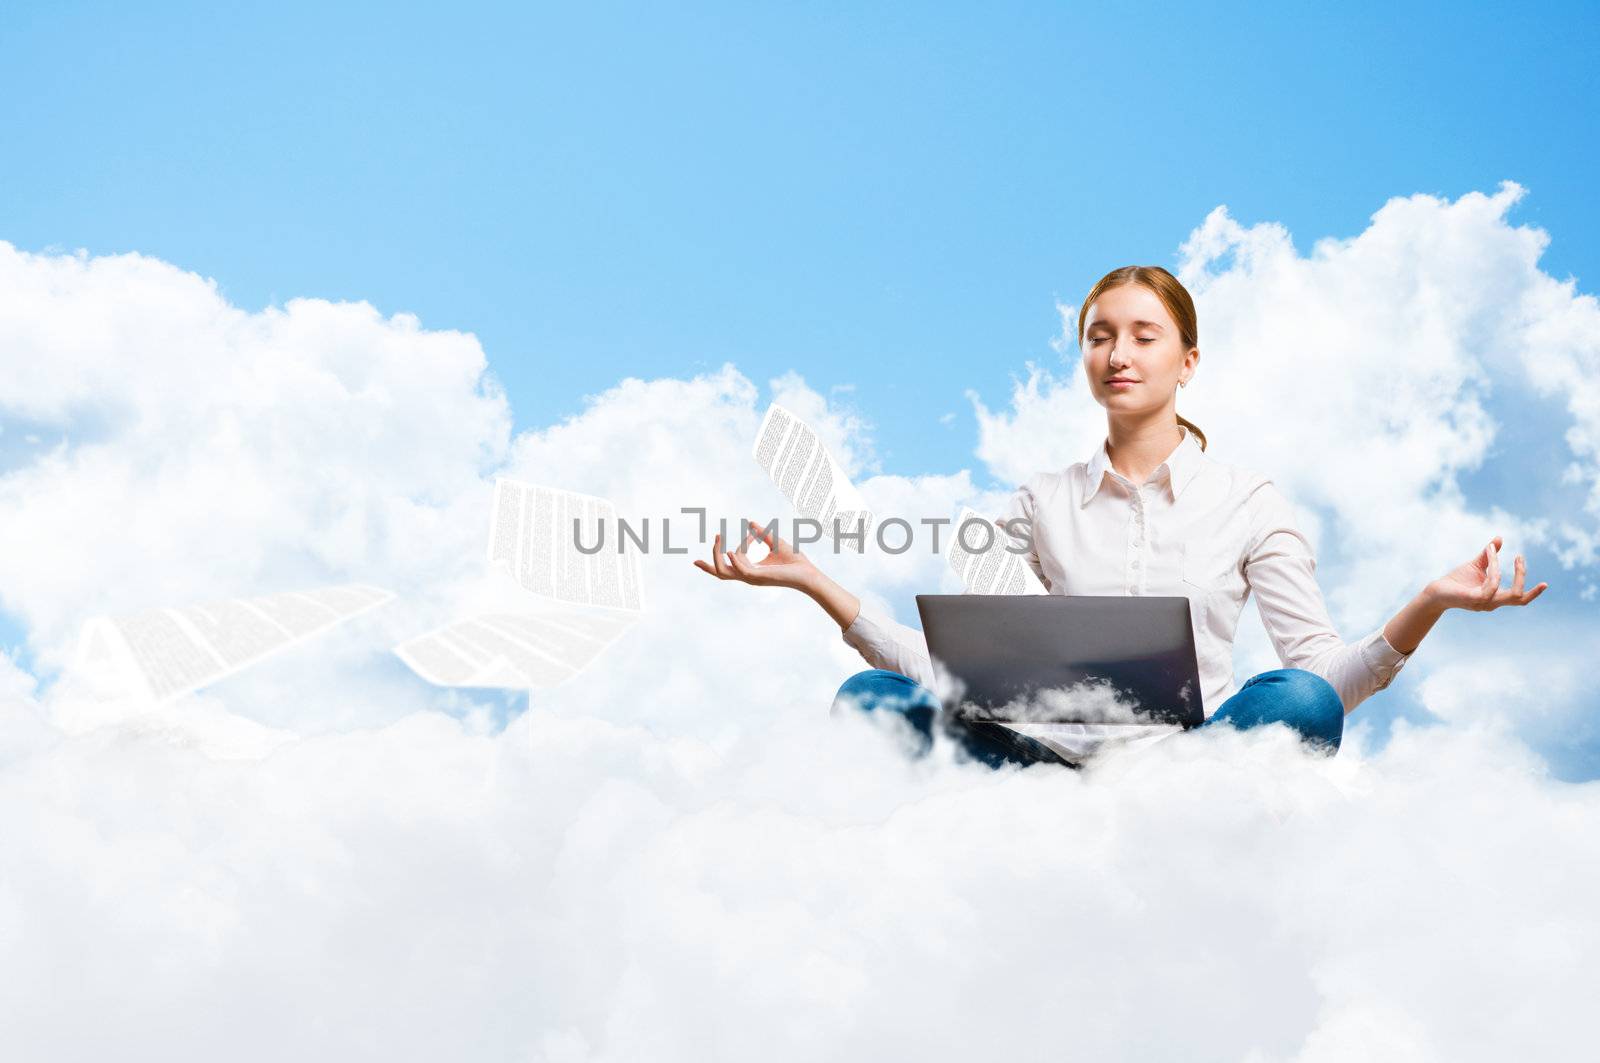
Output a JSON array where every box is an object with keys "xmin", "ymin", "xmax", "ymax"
[{"xmin": 843, "ymin": 426, "xmax": 1410, "ymax": 756}]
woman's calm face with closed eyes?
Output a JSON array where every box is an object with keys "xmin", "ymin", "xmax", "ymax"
[{"xmin": 1083, "ymin": 285, "xmax": 1200, "ymax": 413}]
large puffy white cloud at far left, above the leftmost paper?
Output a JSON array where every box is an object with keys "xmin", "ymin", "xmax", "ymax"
[{"xmin": 0, "ymin": 243, "xmax": 510, "ymax": 668}]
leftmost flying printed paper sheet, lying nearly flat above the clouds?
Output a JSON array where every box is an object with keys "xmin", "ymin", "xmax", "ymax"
[{"xmin": 78, "ymin": 584, "xmax": 394, "ymax": 700}]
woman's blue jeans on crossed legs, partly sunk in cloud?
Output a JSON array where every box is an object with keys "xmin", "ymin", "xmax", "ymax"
[{"xmin": 832, "ymin": 668, "xmax": 1344, "ymax": 768}]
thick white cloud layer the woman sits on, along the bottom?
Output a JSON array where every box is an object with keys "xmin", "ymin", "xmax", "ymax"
[{"xmin": 0, "ymin": 669, "xmax": 1600, "ymax": 1060}]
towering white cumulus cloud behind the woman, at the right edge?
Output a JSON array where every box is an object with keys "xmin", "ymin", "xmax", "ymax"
[{"xmin": 976, "ymin": 183, "xmax": 1600, "ymax": 739}]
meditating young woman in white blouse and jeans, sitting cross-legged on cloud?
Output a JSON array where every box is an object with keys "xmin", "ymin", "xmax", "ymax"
[{"xmin": 694, "ymin": 266, "xmax": 1549, "ymax": 767}]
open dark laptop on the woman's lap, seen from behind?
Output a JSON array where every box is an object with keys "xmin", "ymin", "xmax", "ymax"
[{"xmin": 917, "ymin": 594, "xmax": 1205, "ymax": 730}]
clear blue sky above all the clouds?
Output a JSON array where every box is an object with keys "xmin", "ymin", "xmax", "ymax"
[{"xmin": 0, "ymin": 3, "xmax": 1600, "ymax": 472}]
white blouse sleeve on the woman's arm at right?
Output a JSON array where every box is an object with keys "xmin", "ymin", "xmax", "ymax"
[{"xmin": 1245, "ymin": 480, "xmax": 1411, "ymax": 712}]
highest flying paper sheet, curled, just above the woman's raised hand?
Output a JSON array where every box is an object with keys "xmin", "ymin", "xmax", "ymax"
[{"xmin": 750, "ymin": 402, "xmax": 872, "ymax": 552}]
